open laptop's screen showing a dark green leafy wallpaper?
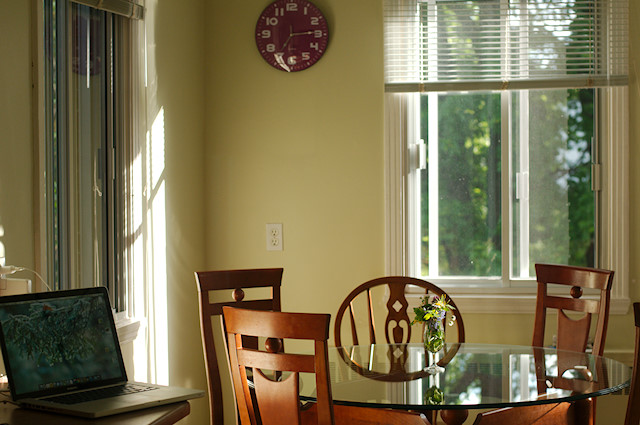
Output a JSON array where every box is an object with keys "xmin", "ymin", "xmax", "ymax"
[{"xmin": 0, "ymin": 287, "xmax": 126, "ymax": 400}]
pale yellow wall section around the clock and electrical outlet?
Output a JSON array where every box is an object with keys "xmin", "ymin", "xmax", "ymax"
[{"xmin": 204, "ymin": 0, "xmax": 384, "ymax": 312}]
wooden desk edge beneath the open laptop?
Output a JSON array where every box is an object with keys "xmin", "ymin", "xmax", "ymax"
[{"xmin": 0, "ymin": 401, "xmax": 191, "ymax": 425}]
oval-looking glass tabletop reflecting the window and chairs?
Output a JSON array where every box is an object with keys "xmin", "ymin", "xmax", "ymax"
[{"xmin": 303, "ymin": 343, "xmax": 631, "ymax": 425}]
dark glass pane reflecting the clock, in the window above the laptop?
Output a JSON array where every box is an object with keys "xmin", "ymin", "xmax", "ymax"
[{"xmin": 69, "ymin": 4, "xmax": 110, "ymax": 285}]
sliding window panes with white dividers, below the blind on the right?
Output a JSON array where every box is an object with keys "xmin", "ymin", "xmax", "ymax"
[{"xmin": 415, "ymin": 89, "xmax": 597, "ymax": 279}]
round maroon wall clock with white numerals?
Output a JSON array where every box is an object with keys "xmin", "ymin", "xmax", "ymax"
[{"xmin": 256, "ymin": 0, "xmax": 329, "ymax": 72}]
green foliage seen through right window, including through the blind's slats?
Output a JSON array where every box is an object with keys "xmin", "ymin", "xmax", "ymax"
[{"xmin": 420, "ymin": 0, "xmax": 595, "ymax": 277}]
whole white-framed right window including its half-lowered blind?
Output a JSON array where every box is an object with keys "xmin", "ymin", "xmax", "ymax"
[{"xmin": 384, "ymin": 0, "xmax": 628, "ymax": 311}]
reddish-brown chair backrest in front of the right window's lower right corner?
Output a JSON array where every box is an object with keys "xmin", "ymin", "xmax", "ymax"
[{"xmin": 532, "ymin": 264, "xmax": 613, "ymax": 356}]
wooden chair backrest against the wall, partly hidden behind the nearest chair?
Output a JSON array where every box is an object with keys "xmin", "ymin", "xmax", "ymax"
[{"xmin": 195, "ymin": 268, "xmax": 283, "ymax": 425}]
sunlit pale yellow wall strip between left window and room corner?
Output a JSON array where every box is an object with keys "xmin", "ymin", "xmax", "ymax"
[{"xmin": 145, "ymin": 0, "xmax": 208, "ymax": 424}]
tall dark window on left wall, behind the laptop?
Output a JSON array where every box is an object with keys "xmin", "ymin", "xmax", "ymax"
[{"xmin": 42, "ymin": 0, "xmax": 142, "ymax": 310}]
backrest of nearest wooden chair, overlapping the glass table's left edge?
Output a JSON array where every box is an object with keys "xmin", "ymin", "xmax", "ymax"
[{"xmin": 223, "ymin": 306, "xmax": 334, "ymax": 425}]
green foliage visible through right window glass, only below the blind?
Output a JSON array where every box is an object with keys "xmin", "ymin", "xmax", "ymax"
[{"xmin": 421, "ymin": 89, "xmax": 595, "ymax": 276}]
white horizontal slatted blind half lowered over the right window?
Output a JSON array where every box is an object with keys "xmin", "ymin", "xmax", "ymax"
[{"xmin": 384, "ymin": 0, "xmax": 629, "ymax": 92}]
